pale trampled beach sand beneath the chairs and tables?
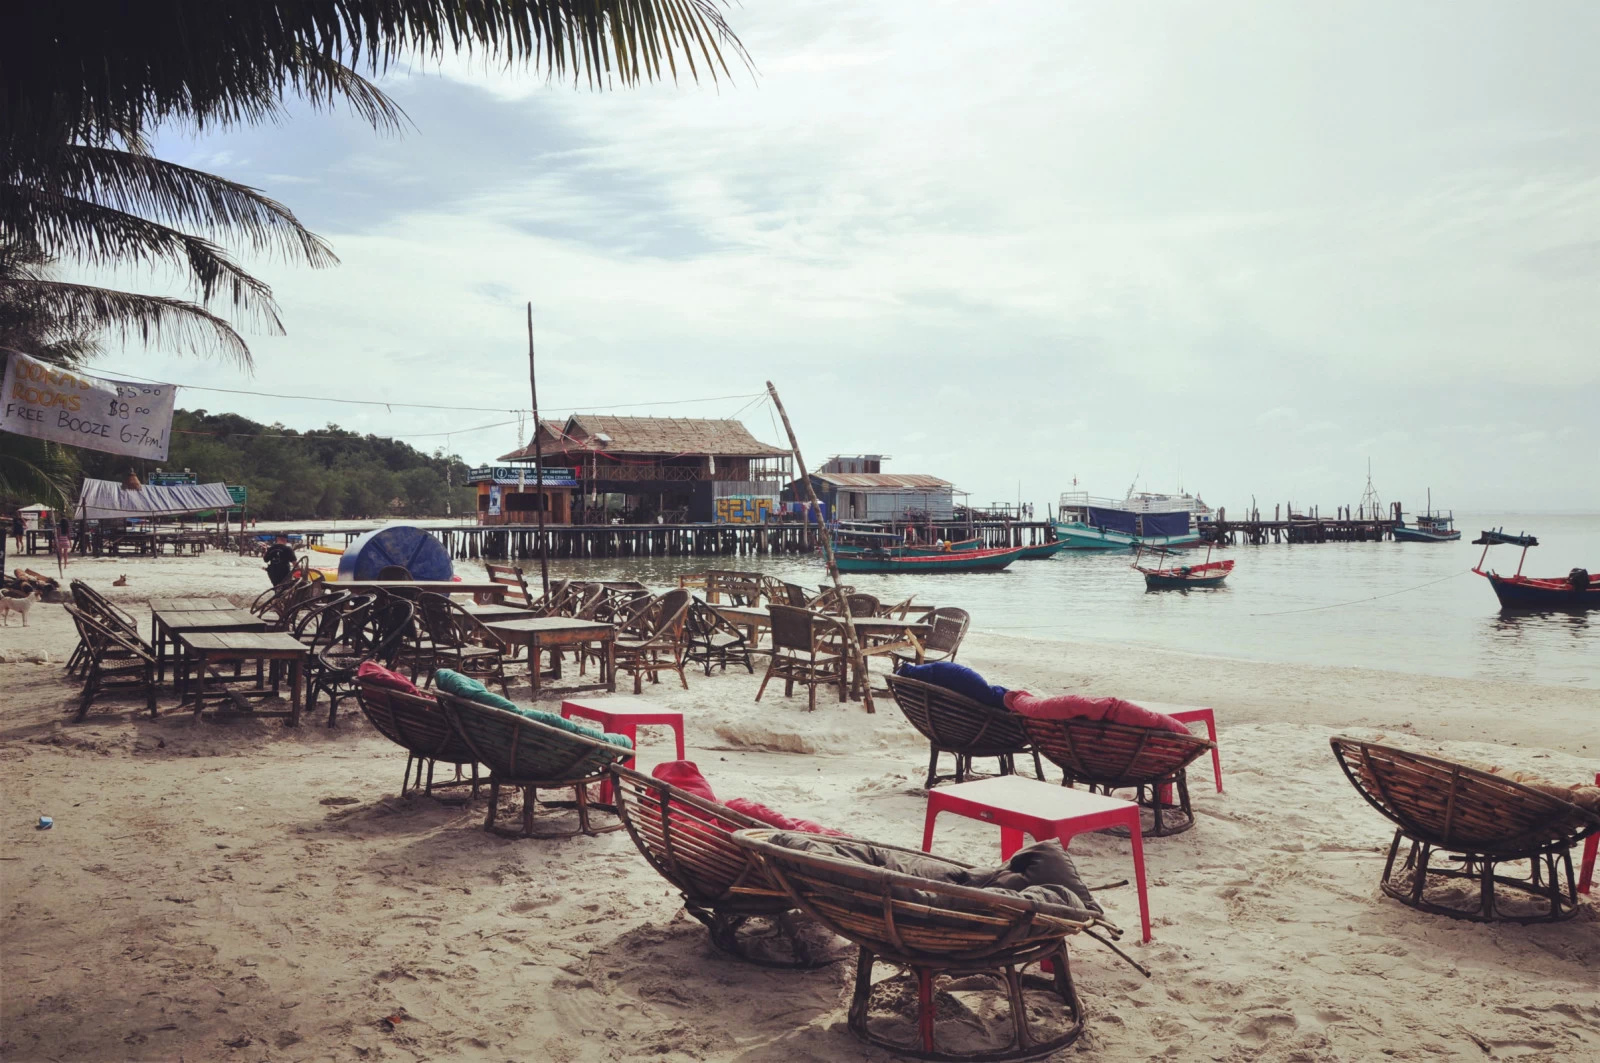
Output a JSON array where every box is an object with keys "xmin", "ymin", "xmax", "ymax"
[{"xmin": 0, "ymin": 554, "xmax": 1600, "ymax": 1063}]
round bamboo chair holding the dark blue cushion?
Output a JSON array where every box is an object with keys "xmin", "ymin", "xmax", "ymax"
[{"xmin": 888, "ymin": 676, "xmax": 1045, "ymax": 789}]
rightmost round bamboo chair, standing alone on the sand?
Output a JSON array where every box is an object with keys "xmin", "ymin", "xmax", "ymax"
[{"xmin": 1328, "ymin": 738, "xmax": 1600, "ymax": 924}]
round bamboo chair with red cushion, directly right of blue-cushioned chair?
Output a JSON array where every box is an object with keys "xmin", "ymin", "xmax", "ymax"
[{"xmin": 1016, "ymin": 716, "xmax": 1211, "ymax": 837}]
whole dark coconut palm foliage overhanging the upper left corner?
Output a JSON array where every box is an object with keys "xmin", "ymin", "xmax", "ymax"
[{"xmin": 0, "ymin": 0, "xmax": 744, "ymax": 363}]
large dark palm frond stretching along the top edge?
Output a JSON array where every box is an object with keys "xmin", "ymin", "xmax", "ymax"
[{"xmin": 0, "ymin": 0, "xmax": 749, "ymax": 144}]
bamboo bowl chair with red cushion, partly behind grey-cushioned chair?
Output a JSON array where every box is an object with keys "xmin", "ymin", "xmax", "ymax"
[{"xmin": 610, "ymin": 764, "xmax": 834, "ymax": 967}]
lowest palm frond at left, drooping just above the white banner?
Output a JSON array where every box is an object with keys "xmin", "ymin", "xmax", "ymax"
[{"xmin": 0, "ymin": 279, "xmax": 250, "ymax": 367}]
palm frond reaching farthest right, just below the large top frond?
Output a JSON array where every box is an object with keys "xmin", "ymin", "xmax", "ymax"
[{"xmin": 0, "ymin": 144, "xmax": 339, "ymax": 267}]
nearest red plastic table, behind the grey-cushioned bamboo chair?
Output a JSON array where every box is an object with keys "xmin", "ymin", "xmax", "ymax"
[{"xmin": 922, "ymin": 775, "xmax": 1150, "ymax": 941}]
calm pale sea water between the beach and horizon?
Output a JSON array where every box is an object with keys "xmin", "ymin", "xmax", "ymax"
[{"xmin": 515, "ymin": 514, "xmax": 1600, "ymax": 688}]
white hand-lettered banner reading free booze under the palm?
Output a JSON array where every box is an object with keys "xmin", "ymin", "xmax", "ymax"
[{"xmin": 0, "ymin": 354, "xmax": 178, "ymax": 461}]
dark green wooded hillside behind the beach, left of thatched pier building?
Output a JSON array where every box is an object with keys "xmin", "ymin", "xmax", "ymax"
[{"xmin": 77, "ymin": 410, "xmax": 477, "ymax": 520}]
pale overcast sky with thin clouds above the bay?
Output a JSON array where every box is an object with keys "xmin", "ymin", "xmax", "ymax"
[{"xmin": 101, "ymin": 0, "xmax": 1600, "ymax": 512}]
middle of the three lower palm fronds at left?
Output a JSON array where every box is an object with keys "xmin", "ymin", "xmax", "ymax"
[{"xmin": 0, "ymin": 183, "xmax": 283, "ymax": 331}]
